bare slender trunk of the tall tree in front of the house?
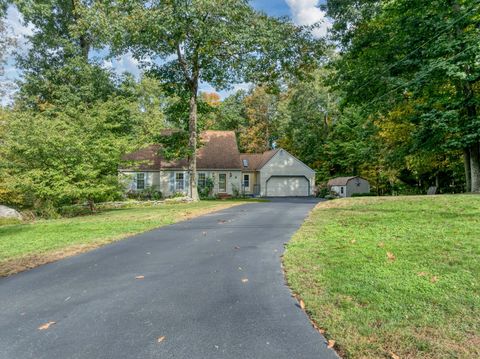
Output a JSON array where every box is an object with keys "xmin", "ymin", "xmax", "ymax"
[{"xmin": 188, "ymin": 85, "xmax": 200, "ymax": 201}]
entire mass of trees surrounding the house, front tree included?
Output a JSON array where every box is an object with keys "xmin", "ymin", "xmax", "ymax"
[{"xmin": 0, "ymin": 0, "xmax": 480, "ymax": 216}]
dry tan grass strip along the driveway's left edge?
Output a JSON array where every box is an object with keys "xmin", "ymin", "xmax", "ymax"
[{"xmin": 0, "ymin": 201, "xmax": 248, "ymax": 278}]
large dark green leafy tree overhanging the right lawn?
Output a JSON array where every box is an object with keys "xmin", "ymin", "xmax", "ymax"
[{"xmin": 327, "ymin": 0, "xmax": 480, "ymax": 192}]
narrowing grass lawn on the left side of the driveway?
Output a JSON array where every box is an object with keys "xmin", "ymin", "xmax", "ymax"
[{"xmin": 0, "ymin": 201, "xmax": 248, "ymax": 276}]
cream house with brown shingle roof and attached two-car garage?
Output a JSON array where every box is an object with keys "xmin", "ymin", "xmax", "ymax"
[{"xmin": 119, "ymin": 131, "xmax": 315, "ymax": 197}]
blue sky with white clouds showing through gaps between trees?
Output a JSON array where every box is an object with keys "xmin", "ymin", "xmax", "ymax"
[{"xmin": 0, "ymin": 0, "xmax": 327, "ymax": 103}]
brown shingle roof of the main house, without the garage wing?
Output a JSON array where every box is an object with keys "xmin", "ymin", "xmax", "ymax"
[{"xmin": 119, "ymin": 131, "xmax": 242, "ymax": 171}]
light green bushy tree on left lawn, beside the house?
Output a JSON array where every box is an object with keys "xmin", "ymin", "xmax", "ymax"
[{"xmin": 0, "ymin": 109, "xmax": 126, "ymax": 213}]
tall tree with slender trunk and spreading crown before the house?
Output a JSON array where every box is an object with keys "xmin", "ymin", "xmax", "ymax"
[{"xmin": 97, "ymin": 0, "xmax": 321, "ymax": 200}]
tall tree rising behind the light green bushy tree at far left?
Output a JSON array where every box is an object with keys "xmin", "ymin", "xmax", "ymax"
[{"xmin": 13, "ymin": 0, "xmax": 109, "ymax": 108}]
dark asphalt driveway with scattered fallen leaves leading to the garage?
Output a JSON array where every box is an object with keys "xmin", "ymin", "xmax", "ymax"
[{"xmin": 0, "ymin": 199, "xmax": 336, "ymax": 359}]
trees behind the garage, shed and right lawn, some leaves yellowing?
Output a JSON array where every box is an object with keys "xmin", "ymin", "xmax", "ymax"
[{"xmin": 205, "ymin": 0, "xmax": 480, "ymax": 194}]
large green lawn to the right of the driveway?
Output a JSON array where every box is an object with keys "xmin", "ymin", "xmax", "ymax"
[{"xmin": 284, "ymin": 195, "xmax": 480, "ymax": 359}]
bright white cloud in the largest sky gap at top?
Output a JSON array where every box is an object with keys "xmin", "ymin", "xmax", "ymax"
[{"xmin": 285, "ymin": 0, "xmax": 330, "ymax": 37}]
